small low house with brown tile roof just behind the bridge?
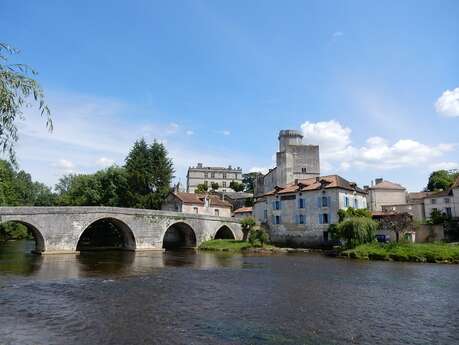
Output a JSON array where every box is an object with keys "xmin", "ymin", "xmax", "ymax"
[{"xmin": 161, "ymin": 192, "xmax": 231, "ymax": 217}]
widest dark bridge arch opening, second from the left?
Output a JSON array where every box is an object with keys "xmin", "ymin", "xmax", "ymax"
[{"xmin": 75, "ymin": 217, "xmax": 136, "ymax": 251}]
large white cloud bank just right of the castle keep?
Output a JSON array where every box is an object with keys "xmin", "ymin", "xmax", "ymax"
[{"xmin": 301, "ymin": 120, "xmax": 455, "ymax": 172}]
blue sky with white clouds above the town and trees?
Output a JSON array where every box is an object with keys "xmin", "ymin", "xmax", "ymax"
[{"xmin": 0, "ymin": 0, "xmax": 459, "ymax": 191}]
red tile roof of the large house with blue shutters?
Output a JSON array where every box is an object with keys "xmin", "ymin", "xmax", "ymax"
[{"xmin": 264, "ymin": 175, "xmax": 366, "ymax": 195}]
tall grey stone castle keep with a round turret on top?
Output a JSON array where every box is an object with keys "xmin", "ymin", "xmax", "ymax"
[{"xmin": 254, "ymin": 129, "xmax": 320, "ymax": 197}]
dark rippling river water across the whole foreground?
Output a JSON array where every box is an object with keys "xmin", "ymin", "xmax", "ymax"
[{"xmin": 0, "ymin": 242, "xmax": 459, "ymax": 345}]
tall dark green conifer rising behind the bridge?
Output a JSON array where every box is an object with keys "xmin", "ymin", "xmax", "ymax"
[{"xmin": 125, "ymin": 138, "xmax": 174, "ymax": 209}]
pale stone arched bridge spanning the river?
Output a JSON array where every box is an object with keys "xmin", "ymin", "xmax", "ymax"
[{"xmin": 0, "ymin": 207, "xmax": 242, "ymax": 254}]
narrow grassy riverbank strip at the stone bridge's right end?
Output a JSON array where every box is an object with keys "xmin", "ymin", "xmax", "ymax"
[{"xmin": 199, "ymin": 240, "xmax": 311, "ymax": 253}]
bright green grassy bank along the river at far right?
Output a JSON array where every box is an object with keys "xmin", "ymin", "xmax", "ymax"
[{"xmin": 342, "ymin": 243, "xmax": 459, "ymax": 263}]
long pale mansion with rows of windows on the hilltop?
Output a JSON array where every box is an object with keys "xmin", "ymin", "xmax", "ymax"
[{"xmin": 186, "ymin": 163, "xmax": 242, "ymax": 193}]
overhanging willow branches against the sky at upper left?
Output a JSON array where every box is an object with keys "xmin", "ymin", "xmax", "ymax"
[{"xmin": 0, "ymin": 43, "xmax": 53, "ymax": 165}]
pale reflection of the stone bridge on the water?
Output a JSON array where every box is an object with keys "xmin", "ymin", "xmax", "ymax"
[{"xmin": 0, "ymin": 241, "xmax": 248, "ymax": 279}]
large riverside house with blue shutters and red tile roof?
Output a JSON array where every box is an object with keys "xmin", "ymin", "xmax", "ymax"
[{"xmin": 253, "ymin": 175, "xmax": 367, "ymax": 247}]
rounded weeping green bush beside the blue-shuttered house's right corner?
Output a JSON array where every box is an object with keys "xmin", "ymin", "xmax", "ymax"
[{"xmin": 336, "ymin": 217, "xmax": 378, "ymax": 248}]
